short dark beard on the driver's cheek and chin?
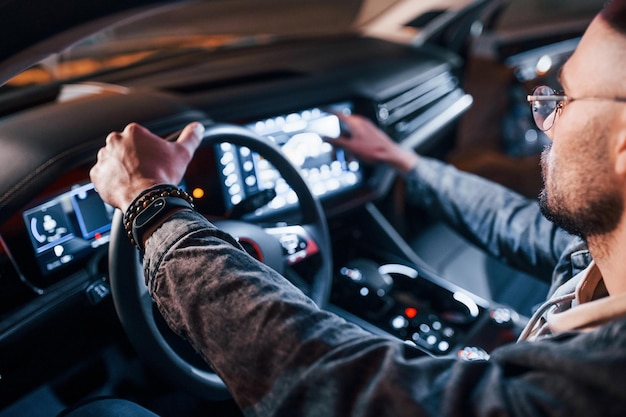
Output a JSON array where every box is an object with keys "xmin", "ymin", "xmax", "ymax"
[{"xmin": 539, "ymin": 146, "xmax": 624, "ymax": 239}]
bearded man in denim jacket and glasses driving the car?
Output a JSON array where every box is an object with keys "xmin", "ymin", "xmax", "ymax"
[{"xmin": 86, "ymin": 0, "xmax": 626, "ymax": 416}]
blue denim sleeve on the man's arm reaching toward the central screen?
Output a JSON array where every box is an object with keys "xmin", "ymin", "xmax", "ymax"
[{"xmin": 406, "ymin": 157, "xmax": 585, "ymax": 285}]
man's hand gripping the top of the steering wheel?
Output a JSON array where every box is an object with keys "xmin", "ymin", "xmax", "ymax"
[{"xmin": 89, "ymin": 122, "xmax": 204, "ymax": 212}]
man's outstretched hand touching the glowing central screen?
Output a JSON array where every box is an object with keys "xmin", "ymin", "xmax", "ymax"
[{"xmin": 328, "ymin": 114, "xmax": 419, "ymax": 172}]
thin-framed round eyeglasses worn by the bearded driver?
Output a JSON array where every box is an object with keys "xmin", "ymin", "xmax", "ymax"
[{"xmin": 526, "ymin": 85, "xmax": 626, "ymax": 132}]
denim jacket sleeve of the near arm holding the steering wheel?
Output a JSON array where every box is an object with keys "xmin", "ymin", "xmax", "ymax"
[{"xmin": 144, "ymin": 212, "xmax": 626, "ymax": 417}]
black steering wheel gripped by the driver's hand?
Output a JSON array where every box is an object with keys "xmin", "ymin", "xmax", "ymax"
[{"xmin": 109, "ymin": 124, "xmax": 332, "ymax": 400}]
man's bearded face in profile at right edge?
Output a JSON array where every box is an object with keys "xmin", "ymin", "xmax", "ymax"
[{"xmin": 539, "ymin": 18, "xmax": 626, "ymax": 238}]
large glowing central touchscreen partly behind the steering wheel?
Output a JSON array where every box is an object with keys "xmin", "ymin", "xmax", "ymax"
[{"xmin": 217, "ymin": 103, "xmax": 362, "ymax": 210}]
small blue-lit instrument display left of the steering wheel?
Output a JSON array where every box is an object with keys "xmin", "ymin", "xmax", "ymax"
[{"xmin": 23, "ymin": 184, "xmax": 113, "ymax": 275}]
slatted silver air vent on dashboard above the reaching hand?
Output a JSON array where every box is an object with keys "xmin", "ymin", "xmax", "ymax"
[{"xmin": 376, "ymin": 72, "xmax": 464, "ymax": 139}]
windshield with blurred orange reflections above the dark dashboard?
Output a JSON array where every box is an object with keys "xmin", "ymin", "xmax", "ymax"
[{"xmin": 6, "ymin": 0, "xmax": 366, "ymax": 89}]
